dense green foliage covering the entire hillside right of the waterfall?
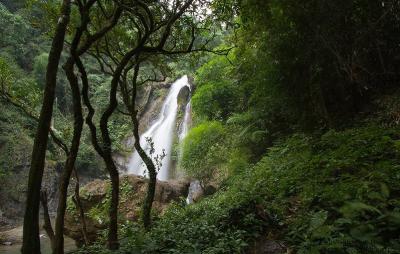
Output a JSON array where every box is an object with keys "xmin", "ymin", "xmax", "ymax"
[{"xmin": 103, "ymin": 0, "xmax": 400, "ymax": 253}]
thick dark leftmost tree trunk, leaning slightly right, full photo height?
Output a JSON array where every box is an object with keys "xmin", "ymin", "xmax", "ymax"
[{"xmin": 21, "ymin": 0, "xmax": 71, "ymax": 254}]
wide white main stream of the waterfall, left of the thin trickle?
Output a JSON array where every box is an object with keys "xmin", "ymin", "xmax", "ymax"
[{"xmin": 128, "ymin": 75, "xmax": 190, "ymax": 180}]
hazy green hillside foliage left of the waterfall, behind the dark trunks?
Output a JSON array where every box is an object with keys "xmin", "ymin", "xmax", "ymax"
[{"xmin": 0, "ymin": 1, "xmax": 134, "ymax": 179}]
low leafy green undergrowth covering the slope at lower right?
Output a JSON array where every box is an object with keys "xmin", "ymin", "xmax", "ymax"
[{"xmin": 74, "ymin": 125, "xmax": 400, "ymax": 254}]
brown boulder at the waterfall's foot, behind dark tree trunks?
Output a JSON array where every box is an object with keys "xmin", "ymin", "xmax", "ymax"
[{"xmin": 65, "ymin": 175, "xmax": 189, "ymax": 245}]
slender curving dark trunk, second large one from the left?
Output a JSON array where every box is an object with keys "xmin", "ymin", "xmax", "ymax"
[{"xmin": 53, "ymin": 57, "xmax": 83, "ymax": 254}]
